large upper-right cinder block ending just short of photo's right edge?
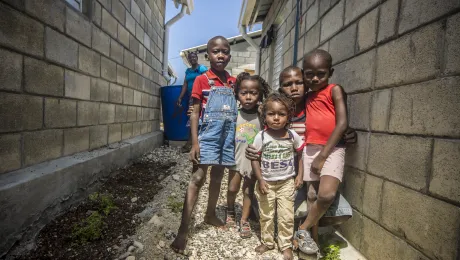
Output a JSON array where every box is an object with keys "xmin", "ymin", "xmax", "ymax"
[{"xmin": 375, "ymin": 23, "xmax": 443, "ymax": 87}]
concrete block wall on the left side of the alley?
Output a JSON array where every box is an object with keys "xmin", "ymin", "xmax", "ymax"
[{"xmin": 0, "ymin": 0, "xmax": 165, "ymax": 174}]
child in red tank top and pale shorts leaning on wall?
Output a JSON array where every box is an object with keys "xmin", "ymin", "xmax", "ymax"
[{"xmin": 295, "ymin": 49, "xmax": 348, "ymax": 254}]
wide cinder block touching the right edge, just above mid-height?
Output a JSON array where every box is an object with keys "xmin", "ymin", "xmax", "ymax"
[{"xmin": 390, "ymin": 77, "xmax": 460, "ymax": 137}]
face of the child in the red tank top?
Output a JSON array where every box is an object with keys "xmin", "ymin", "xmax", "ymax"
[{"xmin": 303, "ymin": 55, "xmax": 334, "ymax": 91}]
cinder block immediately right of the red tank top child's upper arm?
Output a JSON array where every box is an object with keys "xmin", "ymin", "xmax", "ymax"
[{"xmin": 348, "ymin": 92, "xmax": 371, "ymax": 130}]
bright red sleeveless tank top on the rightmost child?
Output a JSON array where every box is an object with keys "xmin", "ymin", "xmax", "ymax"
[{"xmin": 305, "ymin": 84, "xmax": 335, "ymax": 145}]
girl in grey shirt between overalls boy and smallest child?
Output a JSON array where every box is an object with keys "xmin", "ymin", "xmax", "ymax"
[{"xmin": 226, "ymin": 72, "xmax": 270, "ymax": 238}]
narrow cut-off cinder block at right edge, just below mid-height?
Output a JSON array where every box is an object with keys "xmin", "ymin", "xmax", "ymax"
[{"xmin": 430, "ymin": 139, "xmax": 460, "ymax": 202}]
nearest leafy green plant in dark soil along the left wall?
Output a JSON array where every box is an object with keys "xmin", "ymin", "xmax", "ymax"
[{"xmin": 72, "ymin": 211, "xmax": 104, "ymax": 244}]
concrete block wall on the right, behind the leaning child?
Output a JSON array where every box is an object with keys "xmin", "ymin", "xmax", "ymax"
[{"xmin": 261, "ymin": 0, "xmax": 460, "ymax": 260}]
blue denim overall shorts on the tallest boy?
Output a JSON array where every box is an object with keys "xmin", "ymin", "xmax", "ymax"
[{"xmin": 198, "ymin": 74, "xmax": 238, "ymax": 166}]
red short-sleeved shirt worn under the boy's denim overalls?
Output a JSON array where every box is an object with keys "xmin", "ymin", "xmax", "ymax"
[{"xmin": 192, "ymin": 70, "xmax": 236, "ymax": 111}]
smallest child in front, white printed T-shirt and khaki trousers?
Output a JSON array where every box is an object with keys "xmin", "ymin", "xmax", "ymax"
[{"xmin": 252, "ymin": 93, "xmax": 303, "ymax": 259}]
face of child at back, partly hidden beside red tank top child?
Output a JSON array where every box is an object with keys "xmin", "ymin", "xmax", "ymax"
[{"xmin": 280, "ymin": 69, "xmax": 305, "ymax": 104}]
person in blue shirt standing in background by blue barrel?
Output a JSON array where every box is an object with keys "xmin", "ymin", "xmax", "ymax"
[{"xmin": 176, "ymin": 52, "xmax": 208, "ymax": 153}]
